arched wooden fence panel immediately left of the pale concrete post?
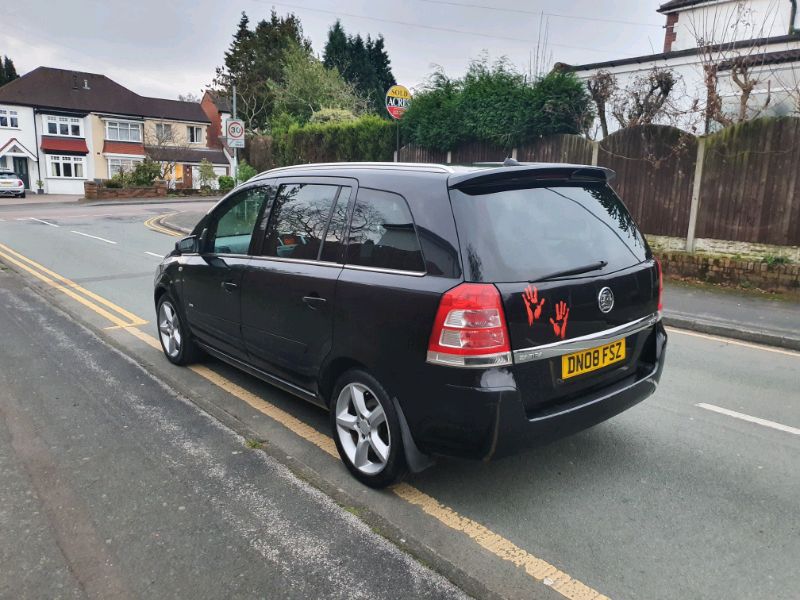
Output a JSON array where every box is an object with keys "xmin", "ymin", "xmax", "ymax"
[{"xmin": 597, "ymin": 125, "xmax": 697, "ymax": 237}]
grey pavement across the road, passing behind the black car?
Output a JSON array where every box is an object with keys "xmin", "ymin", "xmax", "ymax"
[{"xmin": 160, "ymin": 211, "xmax": 800, "ymax": 350}]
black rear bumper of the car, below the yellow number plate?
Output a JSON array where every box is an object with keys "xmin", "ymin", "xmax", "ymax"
[{"xmin": 412, "ymin": 322, "xmax": 667, "ymax": 460}]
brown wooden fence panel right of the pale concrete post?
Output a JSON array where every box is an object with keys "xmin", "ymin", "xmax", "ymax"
[{"xmin": 697, "ymin": 117, "xmax": 800, "ymax": 246}]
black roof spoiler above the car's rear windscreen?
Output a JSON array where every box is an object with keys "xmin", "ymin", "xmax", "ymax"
[{"xmin": 448, "ymin": 163, "xmax": 616, "ymax": 189}]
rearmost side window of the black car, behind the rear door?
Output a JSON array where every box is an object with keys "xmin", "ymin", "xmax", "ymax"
[{"xmin": 347, "ymin": 188, "xmax": 425, "ymax": 272}]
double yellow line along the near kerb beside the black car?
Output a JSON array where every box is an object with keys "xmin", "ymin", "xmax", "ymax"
[{"xmin": 0, "ymin": 241, "xmax": 608, "ymax": 600}]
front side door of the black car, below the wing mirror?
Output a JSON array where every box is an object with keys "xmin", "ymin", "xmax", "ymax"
[{"xmin": 182, "ymin": 185, "xmax": 273, "ymax": 359}]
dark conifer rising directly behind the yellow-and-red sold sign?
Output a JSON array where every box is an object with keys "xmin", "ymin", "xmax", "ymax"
[{"xmin": 323, "ymin": 21, "xmax": 397, "ymax": 113}]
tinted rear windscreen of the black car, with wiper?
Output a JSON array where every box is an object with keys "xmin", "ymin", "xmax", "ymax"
[{"xmin": 450, "ymin": 184, "xmax": 647, "ymax": 283}]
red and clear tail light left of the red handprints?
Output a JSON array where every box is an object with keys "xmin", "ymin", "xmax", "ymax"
[{"xmin": 428, "ymin": 283, "xmax": 511, "ymax": 368}]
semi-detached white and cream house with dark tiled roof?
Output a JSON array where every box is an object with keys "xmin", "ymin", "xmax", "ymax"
[{"xmin": 0, "ymin": 67, "xmax": 230, "ymax": 194}]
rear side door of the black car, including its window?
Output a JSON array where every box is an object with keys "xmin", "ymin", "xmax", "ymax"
[{"xmin": 236, "ymin": 177, "xmax": 356, "ymax": 393}]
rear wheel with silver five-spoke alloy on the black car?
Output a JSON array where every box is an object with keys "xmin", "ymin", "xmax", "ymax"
[{"xmin": 330, "ymin": 369, "xmax": 408, "ymax": 488}]
